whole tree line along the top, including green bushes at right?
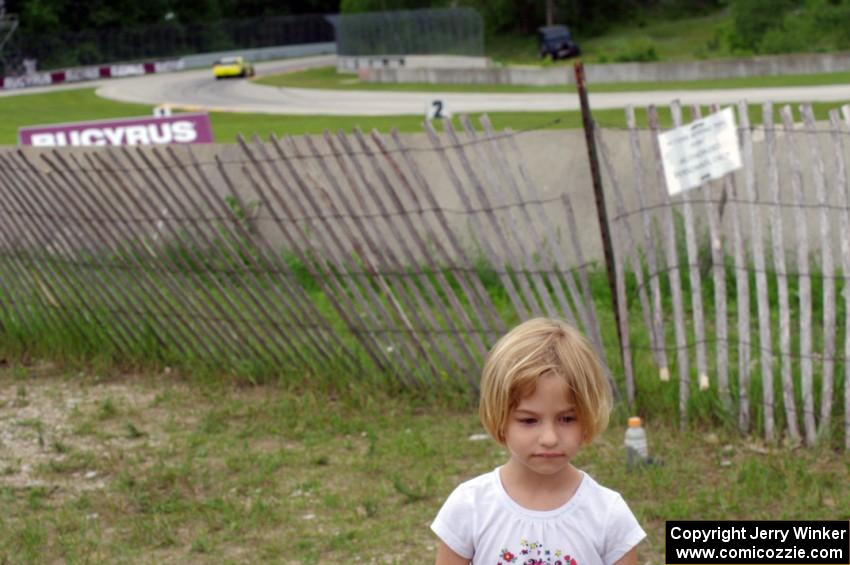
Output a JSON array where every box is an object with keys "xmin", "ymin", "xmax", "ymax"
[{"xmin": 0, "ymin": 0, "xmax": 850, "ymax": 66}]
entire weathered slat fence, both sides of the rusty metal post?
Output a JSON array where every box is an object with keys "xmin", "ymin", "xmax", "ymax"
[{"xmin": 0, "ymin": 99, "xmax": 850, "ymax": 447}]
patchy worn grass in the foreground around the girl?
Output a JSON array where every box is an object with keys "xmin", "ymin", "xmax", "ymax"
[{"xmin": 0, "ymin": 362, "xmax": 850, "ymax": 564}]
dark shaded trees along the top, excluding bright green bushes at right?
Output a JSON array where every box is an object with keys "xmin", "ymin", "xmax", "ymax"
[{"xmin": 5, "ymin": 0, "xmax": 724, "ymax": 36}]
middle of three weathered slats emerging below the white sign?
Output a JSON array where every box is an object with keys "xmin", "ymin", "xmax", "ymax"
[{"xmin": 704, "ymin": 104, "xmax": 732, "ymax": 412}]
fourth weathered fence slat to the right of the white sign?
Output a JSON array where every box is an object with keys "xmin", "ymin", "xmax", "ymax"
[{"xmin": 800, "ymin": 104, "xmax": 836, "ymax": 433}]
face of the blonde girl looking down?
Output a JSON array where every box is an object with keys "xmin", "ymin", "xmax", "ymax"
[{"xmin": 505, "ymin": 374, "xmax": 584, "ymax": 475}]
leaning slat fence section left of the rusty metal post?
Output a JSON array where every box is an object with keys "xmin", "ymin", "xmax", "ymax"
[{"xmin": 0, "ymin": 118, "xmax": 604, "ymax": 388}]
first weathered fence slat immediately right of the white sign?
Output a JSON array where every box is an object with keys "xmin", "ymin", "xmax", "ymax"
[{"xmin": 738, "ymin": 101, "xmax": 774, "ymax": 440}]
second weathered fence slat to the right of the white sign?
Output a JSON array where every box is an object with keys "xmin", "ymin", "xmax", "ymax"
[{"xmin": 762, "ymin": 102, "xmax": 800, "ymax": 441}]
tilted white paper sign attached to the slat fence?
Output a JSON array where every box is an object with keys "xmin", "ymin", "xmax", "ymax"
[{"xmin": 658, "ymin": 108, "xmax": 741, "ymax": 196}]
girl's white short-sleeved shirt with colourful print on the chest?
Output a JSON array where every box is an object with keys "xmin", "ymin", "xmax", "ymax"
[{"xmin": 431, "ymin": 469, "xmax": 646, "ymax": 565}]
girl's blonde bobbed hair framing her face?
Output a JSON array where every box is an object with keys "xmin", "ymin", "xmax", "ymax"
[{"xmin": 478, "ymin": 318, "xmax": 611, "ymax": 443}]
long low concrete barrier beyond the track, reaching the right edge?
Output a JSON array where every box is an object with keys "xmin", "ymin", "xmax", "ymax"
[{"xmin": 361, "ymin": 52, "xmax": 850, "ymax": 86}]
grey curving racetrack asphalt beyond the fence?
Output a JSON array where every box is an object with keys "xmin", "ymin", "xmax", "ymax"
[{"xmin": 6, "ymin": 55, "xmax": 850, "ymax": 116}]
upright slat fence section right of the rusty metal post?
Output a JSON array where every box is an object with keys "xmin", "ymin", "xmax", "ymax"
[{"xmin": 596, "ymin": 102, "xmax": 850, "ymax": 448}]
